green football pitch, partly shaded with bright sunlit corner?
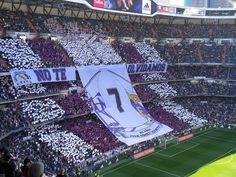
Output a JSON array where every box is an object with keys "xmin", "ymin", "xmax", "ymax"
[{"xmin": 101, "ymin": 128, "xmax": 236, "ymax": 177}]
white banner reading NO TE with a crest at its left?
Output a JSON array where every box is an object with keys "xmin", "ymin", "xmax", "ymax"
[{"xmin": 10, "ymin": 67, "xmax": 76, "ymax": 86}]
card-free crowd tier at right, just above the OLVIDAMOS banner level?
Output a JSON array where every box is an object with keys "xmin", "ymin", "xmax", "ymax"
[{"xmin": 154, "ymin": 42, "xmax": 236, "ymax": 63}]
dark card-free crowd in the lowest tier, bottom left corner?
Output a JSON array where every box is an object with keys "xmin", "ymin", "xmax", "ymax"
[{"xmin": 1, "ymin": 132, "xmax": 76, "ymax": 176}]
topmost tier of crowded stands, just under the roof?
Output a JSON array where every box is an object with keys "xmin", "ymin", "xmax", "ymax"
[{"xmin": 0, "ymin": 10, "xmax": 236, "ymax": 39}]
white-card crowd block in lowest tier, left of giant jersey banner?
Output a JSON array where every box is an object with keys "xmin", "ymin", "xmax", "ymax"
[{"xmin": 32, "ymin": 124, "xmax": 100, "ymax": 164}]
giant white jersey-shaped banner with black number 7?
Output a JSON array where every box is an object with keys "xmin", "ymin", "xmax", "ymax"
[{"xmin": 78, "ymin": 65, "xmax": 172, "ymax": 145}]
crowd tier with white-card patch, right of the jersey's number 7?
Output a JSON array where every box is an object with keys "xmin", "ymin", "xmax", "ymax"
[{"xmin": 135, "ymin": 81, "xmax": 236, "ymax": 101}]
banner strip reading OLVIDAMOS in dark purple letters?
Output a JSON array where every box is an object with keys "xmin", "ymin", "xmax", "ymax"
[{"xmin": 126, "ymin": 63, "xmax": 167, "ymax": 74}]
